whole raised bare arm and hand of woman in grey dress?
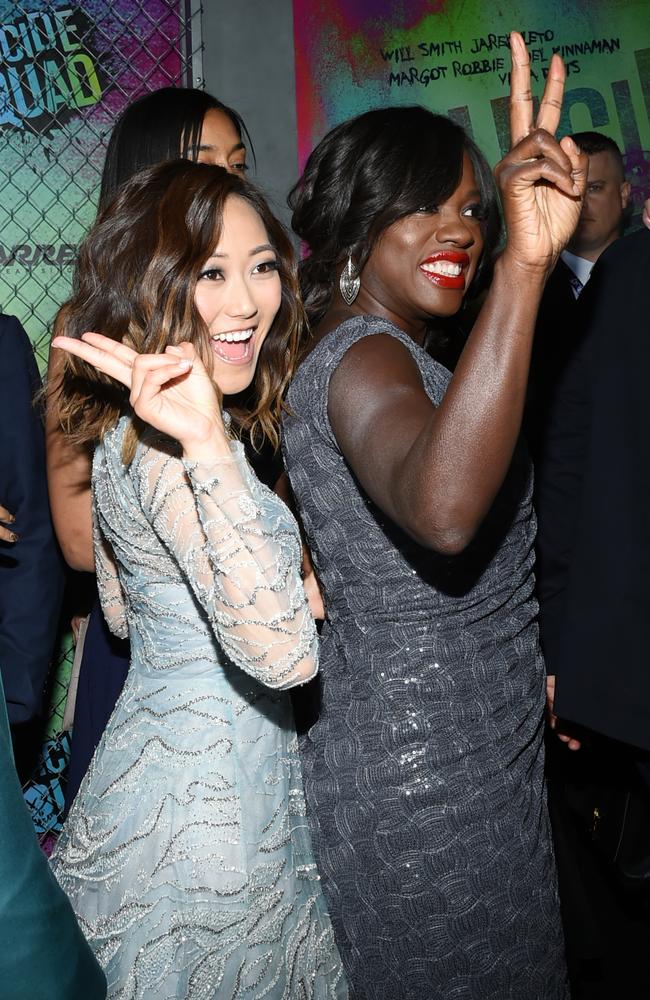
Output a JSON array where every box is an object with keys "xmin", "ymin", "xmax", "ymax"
[{"xmin": 328, "ymin": 36, "xmax": 586, "ymax": 554}]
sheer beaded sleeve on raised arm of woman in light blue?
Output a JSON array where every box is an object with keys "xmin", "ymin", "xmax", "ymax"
[{"xmin": 131, "ymin": 441, "xmax": 317, "ymax": 688}]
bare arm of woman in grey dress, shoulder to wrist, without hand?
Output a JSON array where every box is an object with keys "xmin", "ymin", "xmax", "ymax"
[{"xmin": 328, "ymin": 261, "xmax": 542, "ymax": 554}]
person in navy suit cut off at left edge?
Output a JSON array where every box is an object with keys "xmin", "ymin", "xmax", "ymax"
[{"xmin": 0, "ymin": 315, "xmax": 63, "ymax": 777}]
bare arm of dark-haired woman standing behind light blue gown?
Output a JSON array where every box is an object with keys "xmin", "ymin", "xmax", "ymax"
[{"xmin": 45, "ymin": 340, "xmax": 95, "ymax": 573}]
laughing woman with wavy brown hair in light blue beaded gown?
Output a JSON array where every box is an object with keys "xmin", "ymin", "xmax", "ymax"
[{"xmin": 52, "ymin": 161, "xmax": 347, "ymax": 1000}]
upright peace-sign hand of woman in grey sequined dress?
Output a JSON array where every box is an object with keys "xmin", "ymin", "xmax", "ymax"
[{"xmin": 495, "ymin": 31, "xmax": 588, "ymax": 273}]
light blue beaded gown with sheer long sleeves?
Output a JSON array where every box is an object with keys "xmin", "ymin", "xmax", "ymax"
[{"xmin": 52, "ymin": 418, "xmax": 347, "ymax": 1000}]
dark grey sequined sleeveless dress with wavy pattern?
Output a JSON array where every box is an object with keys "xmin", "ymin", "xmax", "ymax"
[{"xmin": 283, "ymin": 316, "xmax": 568, "ymax": 1000}]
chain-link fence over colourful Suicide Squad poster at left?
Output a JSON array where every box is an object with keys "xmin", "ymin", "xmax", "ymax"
[{"xmin": 0, "ymin": 0, "xmax": 202, "ymax": 848}]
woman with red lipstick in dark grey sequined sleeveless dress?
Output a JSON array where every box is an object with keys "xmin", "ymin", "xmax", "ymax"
[{"xmin": 283, "ymin": 36, "xmax": 585, "ymax": 1000}]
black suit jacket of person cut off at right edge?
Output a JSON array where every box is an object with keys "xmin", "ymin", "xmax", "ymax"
[{"xmin": 538, "ymin": 229, "xmax": 650, "ymax": 751}]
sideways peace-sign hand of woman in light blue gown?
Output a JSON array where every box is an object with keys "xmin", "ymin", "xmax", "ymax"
[{"xmin": 52, "ymin": 333, "xmax": 227, "ymax": 457}]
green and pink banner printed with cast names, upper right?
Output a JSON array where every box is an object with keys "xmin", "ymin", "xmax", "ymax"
[{"xmin": 294, "ymin": 0, "xmax": 650, "ymax": 220}]
